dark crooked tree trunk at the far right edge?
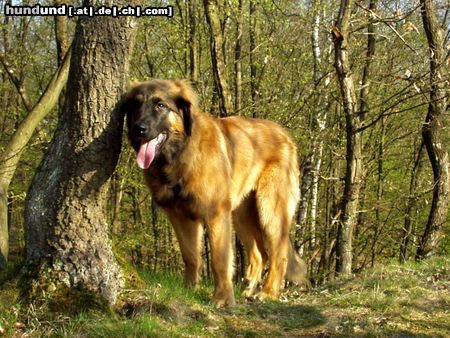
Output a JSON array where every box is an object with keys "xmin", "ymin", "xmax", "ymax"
[{"xmin": 416, "ymin": 0, "xmax": 450, "ymax": 259}]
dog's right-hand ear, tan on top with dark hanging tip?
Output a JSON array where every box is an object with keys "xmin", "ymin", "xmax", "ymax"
[{"xmin": 175, "ymin": 80, "xmax": 198, "ymax": 136}]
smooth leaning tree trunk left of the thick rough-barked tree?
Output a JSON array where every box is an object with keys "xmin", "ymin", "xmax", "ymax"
[{"xmin": 0, "ymin": 52, "xmax": 70, "ymax": 268}]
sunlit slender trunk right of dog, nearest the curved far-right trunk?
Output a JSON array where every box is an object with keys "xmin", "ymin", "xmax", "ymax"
[{"xmin": 332, "ymin": 0, "xmax": 362, "ymax": 275}]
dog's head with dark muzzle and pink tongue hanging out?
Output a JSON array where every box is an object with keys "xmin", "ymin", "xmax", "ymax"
[{"xmin": 122, "ymin": 80, "xmax": 198, "ymax": 169}]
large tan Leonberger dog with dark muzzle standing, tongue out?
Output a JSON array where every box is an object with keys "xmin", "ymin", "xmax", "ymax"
[{"xmin": 122, "ymin": 80, "xmax": 306, "ymax": 307}]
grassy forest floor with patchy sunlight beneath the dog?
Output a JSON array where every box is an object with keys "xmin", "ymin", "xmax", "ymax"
[{"xmin": 0, "ymin": 257, "xmax": 450, "ymax": 338}]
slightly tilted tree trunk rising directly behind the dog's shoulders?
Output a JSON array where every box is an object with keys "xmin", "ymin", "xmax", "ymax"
[{"xmin": 203, "ymin": 0, "xmax": 233, "ymax": 117}]
